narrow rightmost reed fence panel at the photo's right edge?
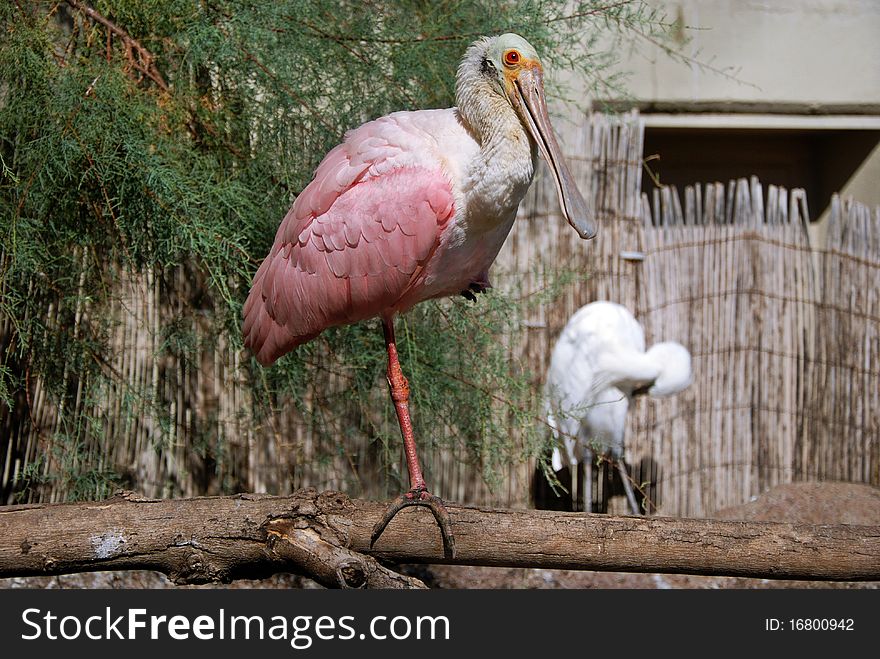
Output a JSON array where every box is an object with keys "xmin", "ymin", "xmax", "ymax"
[{"xmin": 808, "ymin": 195, "xmax": 880, "ymax": 485}]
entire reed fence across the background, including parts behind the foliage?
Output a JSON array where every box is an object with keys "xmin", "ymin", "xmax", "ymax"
[{"xmin": 0, "ymin": 113, "xmax": 880, "ymax": 516}]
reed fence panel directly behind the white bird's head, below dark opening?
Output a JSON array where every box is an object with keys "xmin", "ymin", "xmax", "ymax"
[{"xmin": 629, "ymin": 178, "xmax": 818, "ymax": 516}]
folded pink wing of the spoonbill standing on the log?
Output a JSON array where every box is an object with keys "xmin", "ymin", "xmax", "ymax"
[{"xmin": 243, "ymin": 120, "xmax": 454, "ymax": 365}]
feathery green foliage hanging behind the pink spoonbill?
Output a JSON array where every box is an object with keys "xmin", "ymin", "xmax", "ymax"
[{"xmin": 0, "ymin": 0, "xmax": 672, "ymax": 498}]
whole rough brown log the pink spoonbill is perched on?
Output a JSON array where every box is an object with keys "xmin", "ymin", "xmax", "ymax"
[{"xmin": 0, "ymin": 490, "xmax": 880, "ymax": 588}]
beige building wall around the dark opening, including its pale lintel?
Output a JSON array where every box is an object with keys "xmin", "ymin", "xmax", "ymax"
[{"xmin": 576, "ymin": 0, "xmax": 880, "ymax": 235}]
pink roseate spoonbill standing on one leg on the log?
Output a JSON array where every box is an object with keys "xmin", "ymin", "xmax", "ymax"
[{"xmin": 243, "ymin": 34, "xmax": 595, "ymax": 558}]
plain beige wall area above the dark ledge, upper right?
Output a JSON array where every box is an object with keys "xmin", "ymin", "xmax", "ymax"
[{"xmin": 608, "ymin": 0, "xmax": 880, "ymax": 105}]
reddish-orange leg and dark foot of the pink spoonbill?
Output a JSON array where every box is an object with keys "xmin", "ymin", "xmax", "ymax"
[{"xmin": 370, "ymin": 318, "xmax": 455, "ymax": 559}]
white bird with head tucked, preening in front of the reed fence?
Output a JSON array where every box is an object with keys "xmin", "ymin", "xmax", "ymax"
[{"xmin": 546, "ymin": 302, "xmax": 692, "ymax": 515}]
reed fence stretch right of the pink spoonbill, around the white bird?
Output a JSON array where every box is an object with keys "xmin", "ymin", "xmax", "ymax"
[{"xmin": 499, "ymin": 114, "xmax": 880, "ymax": 516}]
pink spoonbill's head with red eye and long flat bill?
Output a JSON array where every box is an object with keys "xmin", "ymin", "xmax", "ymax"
[{"xmin": 457, "ymin": 33, "xmax": 596, "ymax": 238}]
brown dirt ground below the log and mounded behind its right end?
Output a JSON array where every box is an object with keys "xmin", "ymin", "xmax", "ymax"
[{"xmin": 0, "ymin": 483, "xmax": 880, "ymax": 589}]
